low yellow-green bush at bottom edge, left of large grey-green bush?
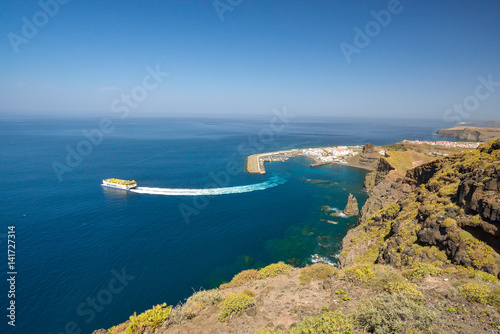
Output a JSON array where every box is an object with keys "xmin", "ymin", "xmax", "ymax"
[{"xmin": 289, "ymin": 312, "xmax": 352, "ymax": 334}]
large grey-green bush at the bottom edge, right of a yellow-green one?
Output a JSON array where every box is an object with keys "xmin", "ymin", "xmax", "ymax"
[{"xmin": 356, "ymin": 291, "xmax": 436, "ymax": 334}]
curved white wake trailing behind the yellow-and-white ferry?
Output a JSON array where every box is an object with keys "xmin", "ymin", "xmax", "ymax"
[{"xmin": 130, "ymin": 176, "xmax": 286, "ymax": 196}]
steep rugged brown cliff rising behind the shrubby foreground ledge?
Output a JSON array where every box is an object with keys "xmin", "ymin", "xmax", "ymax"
[{"xmin": 339, "ymin": 140, "xmax": 500, "ymax": 275}]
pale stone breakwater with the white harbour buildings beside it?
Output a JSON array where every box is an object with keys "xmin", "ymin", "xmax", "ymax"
[{"xmin": 246, "ymin": 146, "xmax": 361, "ymax": 174}]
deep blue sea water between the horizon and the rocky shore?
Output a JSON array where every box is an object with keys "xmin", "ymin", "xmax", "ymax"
[{"xmin": 0, "ymin": 116, "xmax": 454, "ymax": 333}]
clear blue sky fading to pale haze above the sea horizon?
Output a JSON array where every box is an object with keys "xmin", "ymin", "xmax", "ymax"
[{"xmin": 0, "ymin": 0, "xmax": 500, "ymax": 121}]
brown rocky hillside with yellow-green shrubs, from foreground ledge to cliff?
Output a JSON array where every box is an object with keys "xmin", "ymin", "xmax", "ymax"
[{"xmin": 94, "ymin": 140, "xmax": 500, "ymax": 334}]
